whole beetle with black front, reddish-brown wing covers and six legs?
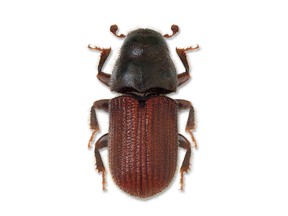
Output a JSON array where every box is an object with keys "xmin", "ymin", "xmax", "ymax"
[{"xmin": 88, "ymin": 25, "xmax": 199, "ymax": 198}]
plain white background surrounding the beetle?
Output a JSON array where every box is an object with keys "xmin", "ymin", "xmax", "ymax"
[{"xmin": 0, "ymin": 0, "xmax": 288, "ymax": 216}]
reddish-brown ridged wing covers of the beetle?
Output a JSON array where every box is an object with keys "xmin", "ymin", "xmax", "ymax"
[{"xmin": 108, "ymin": 96, "xmax": 178, "ymax": 198}]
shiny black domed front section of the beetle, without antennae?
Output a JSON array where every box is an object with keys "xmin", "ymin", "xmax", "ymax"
[{"xmin": 111, "ymin": 29, "xmax": 177, "ymax": 94}]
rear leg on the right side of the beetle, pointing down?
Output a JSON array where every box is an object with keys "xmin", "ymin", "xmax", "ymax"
[{"xmin": 178, "ymin": 134, "xmax": 191, "ymax": 190}]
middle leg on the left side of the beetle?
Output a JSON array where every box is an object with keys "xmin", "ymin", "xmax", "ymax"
[{"xmin": 88, "ymin": 99, "xmax": 109, "ymax": 149}]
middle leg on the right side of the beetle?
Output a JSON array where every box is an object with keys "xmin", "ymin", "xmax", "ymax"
[{"xmin": 176, "ymin": 99, "xmax": 198, "ymax": 149}]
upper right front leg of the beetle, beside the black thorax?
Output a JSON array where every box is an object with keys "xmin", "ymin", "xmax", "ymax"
[{"xmin": 176, "ymin": 44, "xmax": 199, "ymax": 86}]
